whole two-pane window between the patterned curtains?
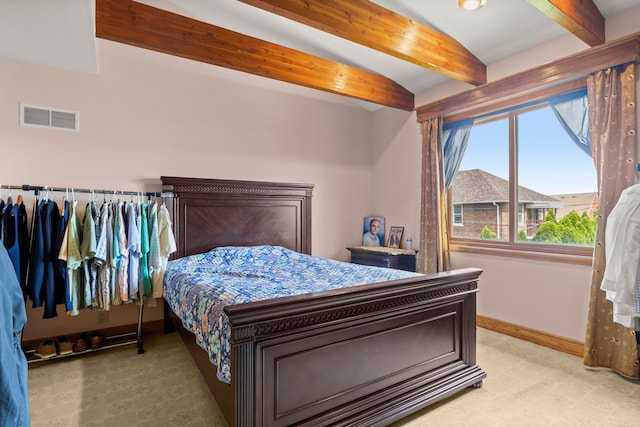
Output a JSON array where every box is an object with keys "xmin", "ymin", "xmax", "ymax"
[{"xmin": 450, "ymin": 98, "xmax": 598, "ymax": 254}]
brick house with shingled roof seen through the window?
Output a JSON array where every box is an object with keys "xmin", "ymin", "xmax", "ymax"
[{"xmin": 451, "ymin": 169, "xmax": 564, "ymax": 240}]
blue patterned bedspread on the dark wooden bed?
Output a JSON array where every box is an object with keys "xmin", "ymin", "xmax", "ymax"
[{"xmin": 164, "ymin": 246, "xmax": 418, "ymax": 383}]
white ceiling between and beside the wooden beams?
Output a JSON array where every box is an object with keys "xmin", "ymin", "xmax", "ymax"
[{"xmin": 0, "ymin": 0, "xmax": 640, "ymax": 103}]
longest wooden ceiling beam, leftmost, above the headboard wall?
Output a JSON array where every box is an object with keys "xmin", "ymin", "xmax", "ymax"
[{"xmin": 96, "ymin": 0, "xmax": 414, "ymax": 111}]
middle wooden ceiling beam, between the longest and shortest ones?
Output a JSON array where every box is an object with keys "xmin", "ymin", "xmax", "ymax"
[{"xmin": 240, "ymin": 0, "xmax": 487, "ymax": 85}]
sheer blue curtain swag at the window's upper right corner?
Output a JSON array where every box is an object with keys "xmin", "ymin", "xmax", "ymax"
[{"xmin": 549, "ymin": 89, "xmax": 591, "ymax": 157}]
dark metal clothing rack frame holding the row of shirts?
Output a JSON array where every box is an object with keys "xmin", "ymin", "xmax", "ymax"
[{"xmin": 0, "ymin": 184, "xmax": 173, "ymax": 363}]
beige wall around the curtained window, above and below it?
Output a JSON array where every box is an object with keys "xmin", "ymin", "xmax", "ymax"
[{"xmin": 373, "ymin": 9, "xmax": 640, "ymax": 341}]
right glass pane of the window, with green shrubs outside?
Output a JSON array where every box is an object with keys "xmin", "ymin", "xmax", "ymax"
[{"xmin": 517, "ymin": 106, "xmax": 598, "ymax": 245}]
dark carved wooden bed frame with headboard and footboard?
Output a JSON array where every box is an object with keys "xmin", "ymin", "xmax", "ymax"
[{"xmin": 162, "ymin": 177, "xmax": 486, "ymax": 427}]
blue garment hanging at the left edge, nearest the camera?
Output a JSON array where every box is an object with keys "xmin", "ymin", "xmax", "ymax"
[{"xmin": 0, "ymin": 245, "xmax": 30, "ymax": 427}]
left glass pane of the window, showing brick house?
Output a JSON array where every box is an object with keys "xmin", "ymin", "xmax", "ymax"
[{"xmin": 451, "ymin": 118, "xmax": 509, "ymax": 241}]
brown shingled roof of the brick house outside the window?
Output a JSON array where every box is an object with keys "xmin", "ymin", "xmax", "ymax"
[{"xmin": 451, "ymin": 169, "xmax": 562, "ymax": 208}]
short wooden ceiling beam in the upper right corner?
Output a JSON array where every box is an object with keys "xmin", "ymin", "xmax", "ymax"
[{"xmin": 528, "ymin": 0, "xmax": 605, "ymax": 47}]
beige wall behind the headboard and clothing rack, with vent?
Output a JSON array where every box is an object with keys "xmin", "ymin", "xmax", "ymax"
[{"xmin": 0, "ymin": 39, "xmax": 373, "ymax": 340}]
